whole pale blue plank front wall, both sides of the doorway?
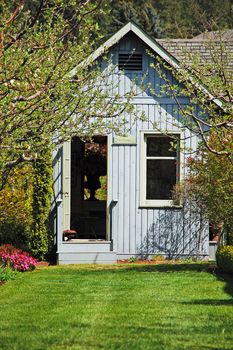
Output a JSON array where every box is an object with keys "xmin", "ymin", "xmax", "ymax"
[{"xmin": 55, "ymin": 34, "xmax": 208, "ymax": 262}]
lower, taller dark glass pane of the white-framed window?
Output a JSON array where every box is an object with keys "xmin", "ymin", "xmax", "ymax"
[{"xmin": 146, "ymin": 159, "xmax": 176, "ymax": 199}]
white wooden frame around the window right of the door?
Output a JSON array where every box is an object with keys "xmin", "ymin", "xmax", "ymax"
[{"xmin": 139, "ymin": 130, "xmax": 184, "ymax": 208}]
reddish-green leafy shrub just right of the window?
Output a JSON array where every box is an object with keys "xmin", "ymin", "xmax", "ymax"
[{"xmin": 174, "ymin": 136, "xmax": 233, "ymax": 244}]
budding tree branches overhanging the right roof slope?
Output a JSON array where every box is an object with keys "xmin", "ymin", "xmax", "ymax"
[{"xmin": 155, "ymin": 33, "xmax": 233, "ymax": 164}]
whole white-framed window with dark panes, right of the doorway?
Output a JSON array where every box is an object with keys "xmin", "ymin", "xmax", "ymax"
[{"xmin": 141, "ymin": 133, "xmax": 180, "ymax": 207}]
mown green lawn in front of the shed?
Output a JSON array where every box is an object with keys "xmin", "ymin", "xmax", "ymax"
[{"xmin": 0, "ymin": 264, "xmax": 233, "ymax": 350}]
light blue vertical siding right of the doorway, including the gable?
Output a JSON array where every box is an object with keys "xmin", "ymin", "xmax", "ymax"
[{"xmin": 109, "ymin": 35, "xmax": 208, "ymax": 257}]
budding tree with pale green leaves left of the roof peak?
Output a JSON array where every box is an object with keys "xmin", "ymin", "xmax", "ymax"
[{"xmin": 0, "ymin": 0, "xmax": 133, "ymax": 187}]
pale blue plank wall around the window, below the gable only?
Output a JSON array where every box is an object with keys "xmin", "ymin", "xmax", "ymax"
[{"xmin": 110, "ymin": 104, "xmax": 208, "ymax": 258}]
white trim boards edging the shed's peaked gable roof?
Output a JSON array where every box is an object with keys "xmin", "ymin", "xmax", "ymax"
[{"xmin": 69, "ymin": 22, "xmax": 222, "ymax": 108}]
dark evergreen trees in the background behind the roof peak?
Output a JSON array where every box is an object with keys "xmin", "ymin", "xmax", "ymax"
[{"xmin": 104, "ymin": 0, "xmax": 233, "ymax": 38}]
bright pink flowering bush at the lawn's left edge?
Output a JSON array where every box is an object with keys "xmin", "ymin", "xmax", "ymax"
[{"xmin": 0, "ymin": 244, "xmax": 37, "ymax": 271}]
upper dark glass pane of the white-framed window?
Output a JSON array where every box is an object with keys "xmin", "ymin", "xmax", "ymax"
[{"xmin": 146, "ymin": 136, "xmax": 176, "ymax": 157}]
